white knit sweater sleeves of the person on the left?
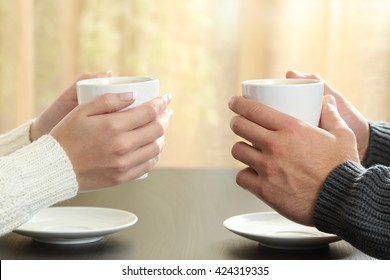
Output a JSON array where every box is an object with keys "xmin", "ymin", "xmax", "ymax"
[{"xmin": 0, "ymin": 122, "xmax": 78, "ymax": 236}]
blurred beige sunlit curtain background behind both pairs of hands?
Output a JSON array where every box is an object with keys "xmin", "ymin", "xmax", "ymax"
[{"xmin": 0, "ymin": 0, "xmax": 390, "ymax": 167}]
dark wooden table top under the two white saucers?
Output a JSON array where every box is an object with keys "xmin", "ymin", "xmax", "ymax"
[{"xmin": 0, "ymin": 169, "xmax": 370, "ymax": 260}]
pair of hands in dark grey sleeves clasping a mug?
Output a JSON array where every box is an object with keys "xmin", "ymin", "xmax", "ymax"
[{"xmin": 229, "ymin": 72, "xmax": 369, "ymax": 225}]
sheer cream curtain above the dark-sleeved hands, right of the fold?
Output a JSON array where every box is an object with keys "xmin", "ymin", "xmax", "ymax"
[{"xmin": 239, "ymin": 0, "xmax": 390, "ymax": 120}]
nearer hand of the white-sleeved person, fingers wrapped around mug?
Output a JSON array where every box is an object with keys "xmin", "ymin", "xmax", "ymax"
[{"xmin": 50, "ymin": 93, "xmax": 172, "ymax": 191}]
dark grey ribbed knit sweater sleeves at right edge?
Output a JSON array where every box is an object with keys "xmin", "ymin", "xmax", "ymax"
[{"xmin": 314, "ymin": 123, "xmax": 390, "ymax": 259}]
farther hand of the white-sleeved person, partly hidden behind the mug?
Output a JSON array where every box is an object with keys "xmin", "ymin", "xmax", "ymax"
[{"xmin": 30, "ymin": 71, "xmax": 111, "ymax": 141}]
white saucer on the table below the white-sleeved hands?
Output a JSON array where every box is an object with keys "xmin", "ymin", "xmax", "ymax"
[{"xmin": 14, "ymin": 207, "xmax": 138, "ymax": 244}]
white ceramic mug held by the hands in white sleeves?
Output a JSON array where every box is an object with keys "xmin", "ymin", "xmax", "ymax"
[{"xmin": 76, "ymin": 76, "xmax": 159, "ymax": 179}]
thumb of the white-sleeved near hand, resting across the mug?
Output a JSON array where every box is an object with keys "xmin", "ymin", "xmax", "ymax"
[{"xmin": 83, "ymin": 92, "xmax": 135, "ymax": 116}]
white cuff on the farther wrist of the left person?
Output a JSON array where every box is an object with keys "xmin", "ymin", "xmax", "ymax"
[{"xmin": 0, "ymin": 120, "xmax": 33, "ymax": 156}]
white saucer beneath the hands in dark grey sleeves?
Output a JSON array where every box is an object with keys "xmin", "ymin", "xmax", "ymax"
[{"xmin": 224, "ymin": 212, "xmax": 340, "ymax": 250}]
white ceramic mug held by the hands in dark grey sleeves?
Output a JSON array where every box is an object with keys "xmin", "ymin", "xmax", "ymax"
[{"xmin": 242, "ymin": 79, "xmax": 324, "ymax": 126}]
